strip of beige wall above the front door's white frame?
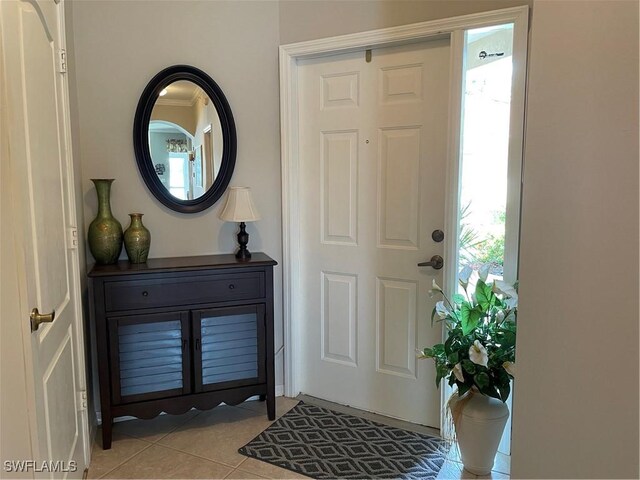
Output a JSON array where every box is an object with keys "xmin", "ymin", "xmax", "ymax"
[{"xmin": 280, "ymin": 0, "xmax": 533, "ymax": 45}]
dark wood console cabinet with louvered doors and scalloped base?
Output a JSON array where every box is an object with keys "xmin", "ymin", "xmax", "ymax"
[{"xmin": 89, "ymin": 253, "xmax": 276, "ymax": 449}]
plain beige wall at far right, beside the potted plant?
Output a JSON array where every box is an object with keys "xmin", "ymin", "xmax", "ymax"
[{"xmin": 512, "ymin": 0, "xmax": 638, "ymax": 478}]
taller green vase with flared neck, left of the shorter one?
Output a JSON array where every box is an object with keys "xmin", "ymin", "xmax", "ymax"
[{"xmin": 88, "ymin": 178, "xmax": 122, "ymax": 265}]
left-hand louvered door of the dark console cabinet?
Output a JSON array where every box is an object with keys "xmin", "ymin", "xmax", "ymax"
[{"xmin": 108, "ymin": 312, "xmax": 191, "ymax": 405}]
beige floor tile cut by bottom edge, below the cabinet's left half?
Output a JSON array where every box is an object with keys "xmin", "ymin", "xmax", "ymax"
[{"xmin": 105, "ymin": 445, "xmax": 233, "ymax": 479}]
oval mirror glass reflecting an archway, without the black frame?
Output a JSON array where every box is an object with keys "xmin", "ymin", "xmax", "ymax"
[{"xmin": 149, "ymin": 80, "xmax": 223, "ymax": 200}]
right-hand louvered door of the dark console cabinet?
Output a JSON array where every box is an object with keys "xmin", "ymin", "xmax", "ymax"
[{"xmin": 192, "ymin": 305, "xmax": 266, "ymax": 392}]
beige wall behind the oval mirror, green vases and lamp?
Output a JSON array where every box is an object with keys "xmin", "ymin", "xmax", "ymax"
[{"xmin": 69, "ymin": 0, "xmax": 283, "ymax": 402}]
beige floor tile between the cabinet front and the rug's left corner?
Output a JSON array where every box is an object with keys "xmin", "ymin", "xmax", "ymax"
[{"xmin": 158, "ymin": 406, "xmax": 272, "ymax": 468}]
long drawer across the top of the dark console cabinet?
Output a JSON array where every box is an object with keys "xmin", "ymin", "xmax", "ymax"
[{"xmin": 104, "ymin": 272, "xmax": 265, "ymax": 312}]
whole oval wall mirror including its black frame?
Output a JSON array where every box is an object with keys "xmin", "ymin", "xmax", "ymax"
[{"xmin": 133, "ymin": 65, "xmax": 236, "ymax": 213}]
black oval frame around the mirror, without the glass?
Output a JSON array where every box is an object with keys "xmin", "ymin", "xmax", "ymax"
[{"xmin": 133, "ymin": 65, "xmax": 237, "ymax": 213}]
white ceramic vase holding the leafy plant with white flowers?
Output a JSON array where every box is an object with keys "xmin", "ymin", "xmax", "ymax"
[{"xmin": 451, "ymin": 390, "xmax": 509, "ymax": 475}]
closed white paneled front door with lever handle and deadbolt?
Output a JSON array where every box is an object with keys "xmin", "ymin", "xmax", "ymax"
[{"xmin": 298, "ymin": 39, "xmax": 450, "ymax": 427}]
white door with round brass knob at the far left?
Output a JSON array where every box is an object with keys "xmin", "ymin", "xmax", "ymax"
[{"xmin": 0, "ymin": 0, "xmax": 88, "ymax": 472}]
